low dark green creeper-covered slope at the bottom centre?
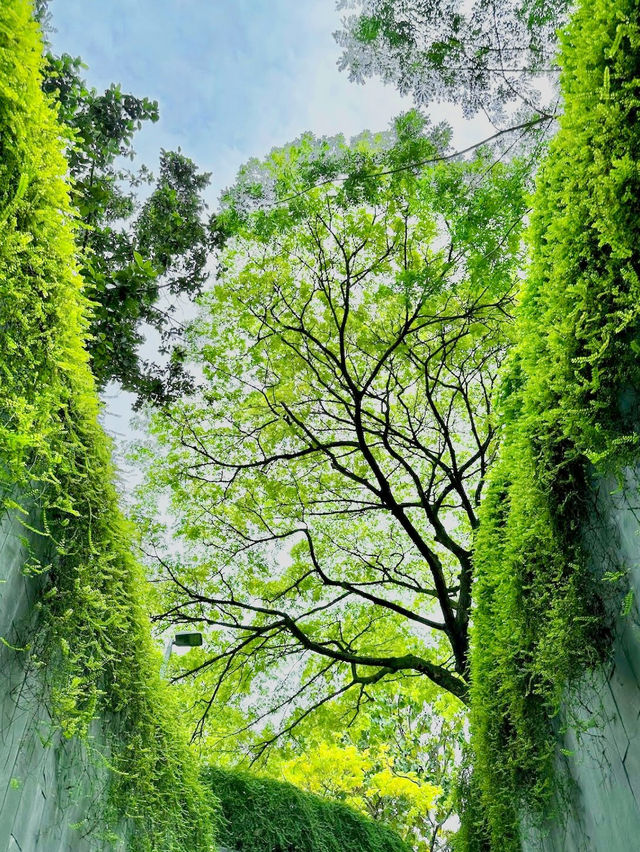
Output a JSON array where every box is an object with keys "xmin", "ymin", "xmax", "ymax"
[{"xmin": 204, "ymin": 767, "xmax": 409, "ymax": 852}]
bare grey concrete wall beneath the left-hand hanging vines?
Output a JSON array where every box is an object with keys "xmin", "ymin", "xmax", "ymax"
[{"xmin": 0, "ymin": 500, "xmax": 124, "ymax": 852}]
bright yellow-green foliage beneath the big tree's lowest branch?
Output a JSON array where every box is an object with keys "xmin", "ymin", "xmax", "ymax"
[{"xmin": 264, "ymin": 678, "xmax": 466, "ymax": 852}]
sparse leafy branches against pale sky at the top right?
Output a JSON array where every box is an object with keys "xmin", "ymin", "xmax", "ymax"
[{"xmin": 335, "ymin": 0, "xmax": 570, "ymax": 119}]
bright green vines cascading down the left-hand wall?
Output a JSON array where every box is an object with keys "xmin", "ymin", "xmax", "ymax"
[{"xmin": 0, "ymin": 0, "xmax": 212, "ymax": 852}]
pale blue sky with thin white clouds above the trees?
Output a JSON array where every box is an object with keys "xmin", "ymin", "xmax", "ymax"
[{"xmin": 49, "ymin": 0, "xmax": 490, "ymax": 466}]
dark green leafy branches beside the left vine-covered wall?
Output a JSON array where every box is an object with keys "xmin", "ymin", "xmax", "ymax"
[{"xmin": 40, "ymin": 41, "xmax": 210, "ymax": 405}]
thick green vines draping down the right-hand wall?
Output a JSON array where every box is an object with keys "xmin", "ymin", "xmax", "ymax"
[{"xmin": 462, "ymin": 0, "xmax": 640, "ymax": 852}]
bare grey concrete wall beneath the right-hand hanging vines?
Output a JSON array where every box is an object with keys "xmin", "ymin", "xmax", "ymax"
[{"xmin": 523, "ymin": 474, "xmax": 640, "ymax": 852}]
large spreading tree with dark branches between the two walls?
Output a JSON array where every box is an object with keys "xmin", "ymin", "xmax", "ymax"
[{"xmin": 140, "ymin": 113, "xmax": 527, "ymax": 747}]
